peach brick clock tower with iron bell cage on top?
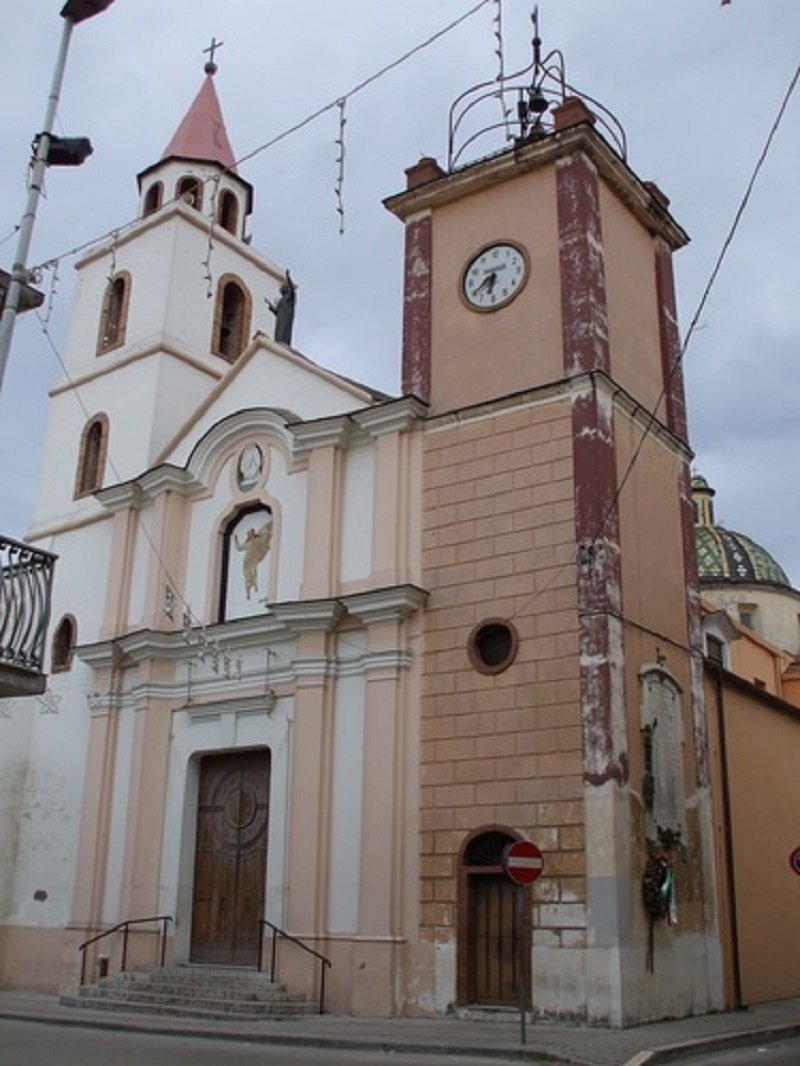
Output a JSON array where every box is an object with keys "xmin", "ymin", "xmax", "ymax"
[{"xmin": 386, "ymin": 20, "xmax": 719, "ymax": 1024}]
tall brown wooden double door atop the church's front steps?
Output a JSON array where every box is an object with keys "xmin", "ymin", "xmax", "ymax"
[{"xmin": 191, "ymin": 749, "xmax": 270, "ymax": 966}]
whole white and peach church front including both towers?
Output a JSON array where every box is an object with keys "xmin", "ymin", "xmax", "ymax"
[{"xmin": 0, "ymin": 45, "xmax": 721, "ymax": 1024}]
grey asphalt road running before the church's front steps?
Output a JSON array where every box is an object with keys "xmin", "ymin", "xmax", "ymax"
[{"xmin": 0, "ymin": 1020, "xmax": 514, "ymax": 1066}]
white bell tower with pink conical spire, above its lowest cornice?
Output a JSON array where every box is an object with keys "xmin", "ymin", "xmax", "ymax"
[{"xmin": 31, "ymin": 61, "xmax": 285, "ymax": 535}]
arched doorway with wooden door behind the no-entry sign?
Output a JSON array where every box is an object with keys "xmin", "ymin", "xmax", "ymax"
[{"xmin": 458, "ymin": 827, "xmax": 530, "ymax": 1006}]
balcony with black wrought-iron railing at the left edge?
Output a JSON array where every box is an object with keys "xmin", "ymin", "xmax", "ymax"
[{"xmin": 0, "ymin": 535, "xmax": 55, "ymax": 696}]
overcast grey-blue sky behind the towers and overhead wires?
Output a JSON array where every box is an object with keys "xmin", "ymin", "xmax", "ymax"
[{"xmin": 0, "ymin": 0, "xmax": 800, "ymax": 587}]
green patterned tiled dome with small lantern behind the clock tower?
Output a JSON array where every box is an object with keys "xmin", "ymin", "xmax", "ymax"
[{"xmin": 691, "ymin": 477, "xmax": 791, "ymax": 588}]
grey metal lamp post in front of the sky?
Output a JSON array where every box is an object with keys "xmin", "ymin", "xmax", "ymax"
[{"xmin": 0, "ymin": 17, "xmax": 75, "ymax": 391}]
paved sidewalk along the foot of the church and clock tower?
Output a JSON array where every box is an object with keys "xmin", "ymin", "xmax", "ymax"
[{"xmin": 0, "ymin": 989, "xmax": 800, "ymax": 1066}]
